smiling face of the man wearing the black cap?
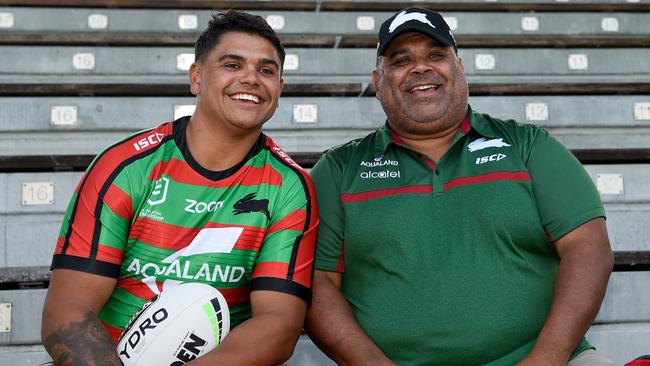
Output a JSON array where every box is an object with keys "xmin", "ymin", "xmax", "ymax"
[{"xmin": 372, "ymin": 32, "xmax": 468, "ymax": 135}]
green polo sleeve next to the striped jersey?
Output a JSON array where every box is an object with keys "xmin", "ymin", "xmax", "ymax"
[{"xmin": 310, "ymin": 152, "xmax": 344, "ymax": 272}]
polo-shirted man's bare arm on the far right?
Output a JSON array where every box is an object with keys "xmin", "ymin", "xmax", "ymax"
[{"xmin": 519, "ymin": 218, "xmax": 614, "ymax": 366}]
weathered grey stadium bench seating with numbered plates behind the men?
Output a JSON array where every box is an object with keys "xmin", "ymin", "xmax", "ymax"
[{"xmin": 0, "ymin": 0, "xmax": 650, "ymax": 366}]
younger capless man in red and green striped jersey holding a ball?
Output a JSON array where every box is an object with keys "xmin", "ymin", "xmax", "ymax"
[{"xmin": 42, "ymin": 11, "xmax": 318, "ymax": 366}]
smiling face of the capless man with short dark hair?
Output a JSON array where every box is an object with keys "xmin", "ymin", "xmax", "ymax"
[{"xmin": 189, "ymin": 31, "xmax": 283, "ymax": 135}]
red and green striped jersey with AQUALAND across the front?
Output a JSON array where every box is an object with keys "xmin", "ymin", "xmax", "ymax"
[{"xmin": 51, "ymin": 117, "xmax": 318, "ymax": 340}]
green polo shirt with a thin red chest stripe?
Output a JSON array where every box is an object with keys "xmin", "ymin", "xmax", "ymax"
[{"xmin": 311, "ymin": 109, "xmax": 605, "ymax": 365}]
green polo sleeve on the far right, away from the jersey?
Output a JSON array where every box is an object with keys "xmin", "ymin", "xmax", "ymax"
[{"xmin": 526, "ymin": 128, "xmax": 605, "ymax": 241}]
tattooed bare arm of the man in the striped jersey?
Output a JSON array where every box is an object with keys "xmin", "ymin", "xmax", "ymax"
[{"xmin": 41, "ymin": 269, "xmax": 121, "ymax": 366}]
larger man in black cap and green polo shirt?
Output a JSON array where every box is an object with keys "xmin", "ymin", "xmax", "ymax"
[{"xmin": 307, "ymin": 8, "xmax": 613, "ymax": 366}]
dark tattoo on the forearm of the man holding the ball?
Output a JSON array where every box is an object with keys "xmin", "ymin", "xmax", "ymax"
[{"xmin": 44, "ymin": 312, "xmax": 122, "ymax": 366}]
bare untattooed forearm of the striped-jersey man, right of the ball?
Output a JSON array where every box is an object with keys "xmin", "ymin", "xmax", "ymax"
[{"xmin": 187, "ymin": 291, "xmax": 307, "ymax": 366}]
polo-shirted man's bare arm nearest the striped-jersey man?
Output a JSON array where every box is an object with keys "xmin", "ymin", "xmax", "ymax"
[{"xmin": 305, "ymin": 270, "xmax": 395, "ymax": 366}]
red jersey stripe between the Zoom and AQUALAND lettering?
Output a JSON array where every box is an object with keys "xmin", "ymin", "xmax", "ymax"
[{"xmin": 129, "ymin": 217, "xmax": 266, "ymax": 250}]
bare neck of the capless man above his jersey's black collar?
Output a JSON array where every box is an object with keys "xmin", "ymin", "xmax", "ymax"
[{"xmin": 186, "ymin": 116, "xmax": 261, "ymax": 171}]
